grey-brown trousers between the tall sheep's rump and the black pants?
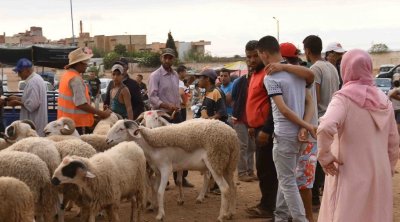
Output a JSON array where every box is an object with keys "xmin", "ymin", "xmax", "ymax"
[{"xmin": 232, "ymin": 122, "xmax": 256, "ymax": 176}]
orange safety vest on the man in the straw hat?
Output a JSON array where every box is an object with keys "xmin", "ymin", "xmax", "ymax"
[{"xmin": 57, "ymin": 70, "xmax": 94, "ymax": 127}]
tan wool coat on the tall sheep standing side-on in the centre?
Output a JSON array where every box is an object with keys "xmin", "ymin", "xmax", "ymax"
[{"xmin": 140, "ymin": 119, "xmax": 239, "ymax": 175}]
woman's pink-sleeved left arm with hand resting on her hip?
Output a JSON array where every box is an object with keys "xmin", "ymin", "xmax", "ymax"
[{"xmin": 317, "ymin": 96, "xmax": 346, "ymax": 175}]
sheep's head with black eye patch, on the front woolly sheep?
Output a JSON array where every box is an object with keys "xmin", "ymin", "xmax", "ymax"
[{"xmin": 51, "ymin": 156, "xmax": 96, "ymax": 186}]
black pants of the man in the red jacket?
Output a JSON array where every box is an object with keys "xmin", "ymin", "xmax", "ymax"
[{"xmin": 256, "ymin": 129, "xmax": 278, "ymax": 211}]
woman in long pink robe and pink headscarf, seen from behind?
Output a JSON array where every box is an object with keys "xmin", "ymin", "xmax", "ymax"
[{"xmin": 317, "ymin": 49, "xmax": 399, "ymax": 222}]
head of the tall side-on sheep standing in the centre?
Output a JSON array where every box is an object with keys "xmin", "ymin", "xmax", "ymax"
[{"xmin": 107, "ymin": 120, "xmax": 140, "ymax": 144}]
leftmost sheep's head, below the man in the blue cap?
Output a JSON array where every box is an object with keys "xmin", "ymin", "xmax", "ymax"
[{"xmin": 4, "ymin": 120, "xmax": 38, "ymax": 143}]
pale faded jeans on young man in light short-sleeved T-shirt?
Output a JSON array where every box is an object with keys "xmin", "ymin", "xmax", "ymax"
[{"xmin": 273, "ymin": 136, "xmax": 308, "ymax": 222}]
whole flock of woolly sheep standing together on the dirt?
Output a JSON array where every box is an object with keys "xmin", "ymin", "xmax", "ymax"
[{"xmin": 0, "ymin": 111, "xmax": 239, "ymax": 222}]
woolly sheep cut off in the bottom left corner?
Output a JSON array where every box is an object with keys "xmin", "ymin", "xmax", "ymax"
[{"xmin": 0, "ymin": 177, "xmax": 35, "ymax": 222}]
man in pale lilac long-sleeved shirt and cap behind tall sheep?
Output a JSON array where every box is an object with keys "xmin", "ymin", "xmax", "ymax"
[{"xmin": 148, "ymin": 48, "xmax": 194, "ymax": 187}]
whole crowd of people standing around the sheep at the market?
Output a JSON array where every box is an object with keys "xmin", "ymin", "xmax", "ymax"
[{"xmin": 0, "ymin": 35, "xmax": 400, "ymax": 222}]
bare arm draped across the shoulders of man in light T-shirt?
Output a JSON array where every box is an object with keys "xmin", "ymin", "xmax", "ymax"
[{"xmin": 265, "ymin": 63, "xmax": 314, "ymax": 85}]
